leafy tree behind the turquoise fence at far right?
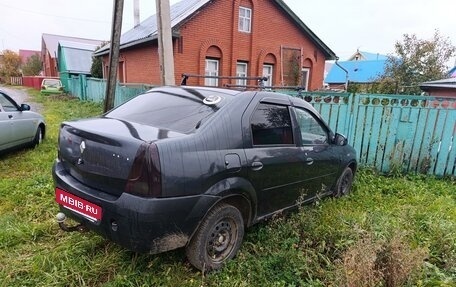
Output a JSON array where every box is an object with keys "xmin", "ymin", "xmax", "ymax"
[{"xmin": 377, "ymin": 30, "xmax": 456, "ymax": 94}]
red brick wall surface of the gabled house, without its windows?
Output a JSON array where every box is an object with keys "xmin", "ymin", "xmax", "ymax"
[{"xmin": 105, "ymin": 0, "xmax": 325, "ymax": 90}]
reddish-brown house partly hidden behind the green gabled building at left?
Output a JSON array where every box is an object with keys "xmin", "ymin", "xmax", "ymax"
[{"xmin": 41, "ymin": 34, "xmax": 102, "ymax": 77}]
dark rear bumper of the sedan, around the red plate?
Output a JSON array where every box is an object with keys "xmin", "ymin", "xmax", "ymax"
[{"xmin": 52, "ymin": 160, "xmax": 218, "ymax": 253}]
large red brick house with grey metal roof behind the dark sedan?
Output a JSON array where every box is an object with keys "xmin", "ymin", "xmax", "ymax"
[{"xmin": 95, "ymin": 0, "xmax": 336, "ymax": 90}]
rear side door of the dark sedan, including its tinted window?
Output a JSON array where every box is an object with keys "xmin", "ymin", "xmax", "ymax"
[{"xmin": 242, "ymin": 95, "xmax": 305, "ymax": 217}]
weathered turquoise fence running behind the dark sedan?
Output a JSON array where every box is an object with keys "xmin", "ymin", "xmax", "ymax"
[{"xmin": 63, "ymin": 79, "xmax": 456, "ymax": 176}]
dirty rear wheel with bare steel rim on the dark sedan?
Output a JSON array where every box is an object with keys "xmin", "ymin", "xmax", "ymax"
[{"xmin": 186, "ymin": 204, "xmax": 244, "ymax": 271}]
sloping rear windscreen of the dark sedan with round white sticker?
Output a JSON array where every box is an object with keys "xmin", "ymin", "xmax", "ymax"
[{"xmin": 106, "ymin": 88, "xmax": 229, "ymax": 134}]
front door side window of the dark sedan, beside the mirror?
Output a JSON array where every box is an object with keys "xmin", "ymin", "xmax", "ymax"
[{"xmin": 295, "ymin": 108, "xmax": 328, "ymax": 145}]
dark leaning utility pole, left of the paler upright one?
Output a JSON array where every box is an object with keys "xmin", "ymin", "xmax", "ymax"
[{"xmin": 104, "ymin": 0, "xmax": 124, "ymax": 113}]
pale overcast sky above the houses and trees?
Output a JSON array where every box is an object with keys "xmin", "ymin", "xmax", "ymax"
[{"xmin": 0, "ymin": 0, "xmax": 456, "ymax": 60}]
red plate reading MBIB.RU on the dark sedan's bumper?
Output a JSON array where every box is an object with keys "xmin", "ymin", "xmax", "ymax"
[{"xmin": 55, "ymin": 188, "xmax": 102, "ymax": 221}]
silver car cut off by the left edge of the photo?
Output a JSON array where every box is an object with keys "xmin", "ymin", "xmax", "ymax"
[{"xmin": 0, "ymin": 90, "xmax": 46, "ymax": 152}]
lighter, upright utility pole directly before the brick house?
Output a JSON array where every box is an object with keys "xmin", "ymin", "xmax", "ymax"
[{"xmin": 155, "ymin": 0, "xmax": 175, "ymax": 85}]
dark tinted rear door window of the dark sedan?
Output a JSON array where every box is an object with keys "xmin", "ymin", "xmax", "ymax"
[{"xmin": 250, "ymin": 103, "xmax": 293, "ymax": 145}]
